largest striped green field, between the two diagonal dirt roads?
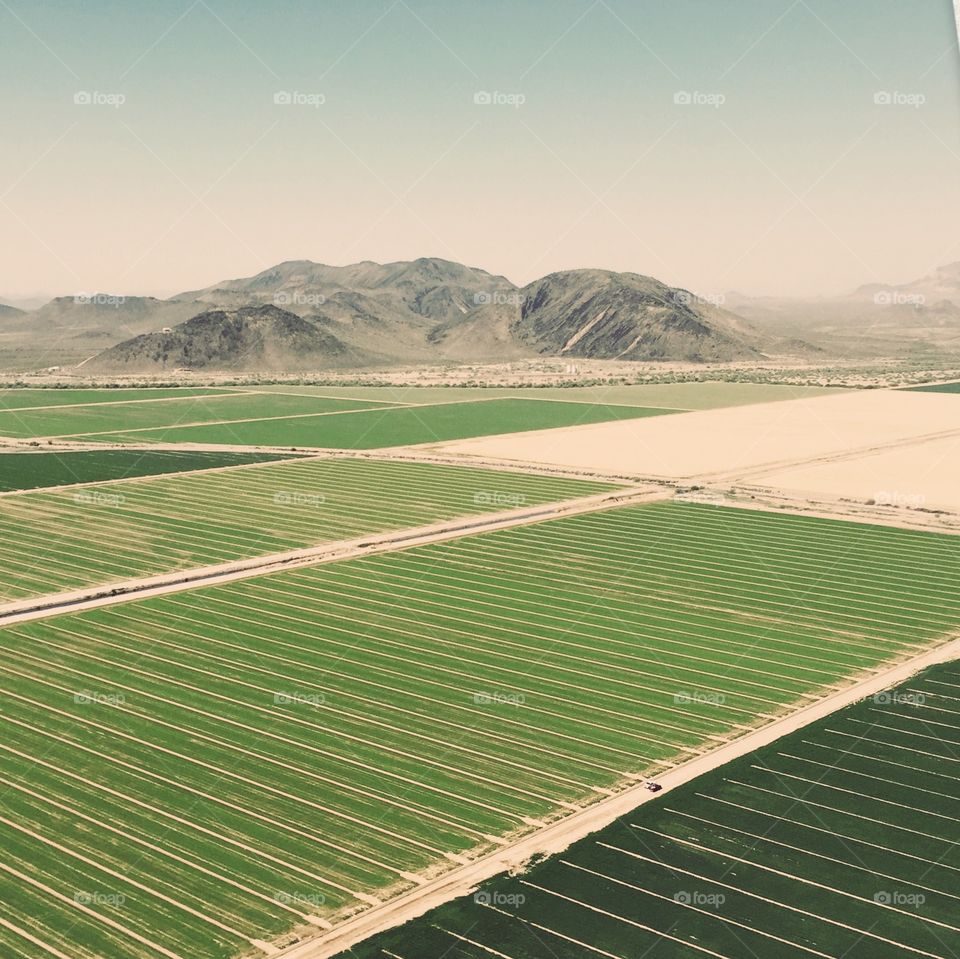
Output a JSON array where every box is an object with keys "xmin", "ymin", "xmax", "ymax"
[{"xmin": 0, "ymin": 503, "xmax": 960, "ymax": 959}]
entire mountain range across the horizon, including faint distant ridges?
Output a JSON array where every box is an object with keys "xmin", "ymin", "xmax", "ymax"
[{"xmin": 7, "ymin": 258, "xmax": 960, "ymax": 373}]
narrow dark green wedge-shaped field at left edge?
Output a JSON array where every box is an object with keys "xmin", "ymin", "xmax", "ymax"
[{"xmin": 0, "ymin": 449, "xmax": 294, "ymax": 493}]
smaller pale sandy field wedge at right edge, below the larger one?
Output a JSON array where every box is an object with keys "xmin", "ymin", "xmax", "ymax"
[{"xmin": 756, "ymin": 433, "xmax": 960, "ymax": 513}]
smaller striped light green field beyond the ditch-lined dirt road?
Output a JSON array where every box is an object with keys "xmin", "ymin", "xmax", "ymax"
[{"xmin": 0, "ymin": 458, "xmax": 614, "ymax": 602}]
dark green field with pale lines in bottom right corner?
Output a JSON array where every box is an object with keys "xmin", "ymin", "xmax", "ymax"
[{"xmin": 343, "ymin": 663, "xmax": 960, "ymax": 959}]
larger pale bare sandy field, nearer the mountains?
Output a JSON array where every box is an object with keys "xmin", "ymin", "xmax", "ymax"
[{"xmin": 440, "ymin": 390, "xmax": 960, "ymax": 482}]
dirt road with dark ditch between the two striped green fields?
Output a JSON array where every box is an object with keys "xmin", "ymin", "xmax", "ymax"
[{"xmin": 0, "ymin": 484, "xmax": 668, "ymax": 626}]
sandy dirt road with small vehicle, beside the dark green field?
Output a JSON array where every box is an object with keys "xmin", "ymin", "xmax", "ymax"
[{"xmin": 280, "ymin": 634, "xmax": 960, "ymax": 959}]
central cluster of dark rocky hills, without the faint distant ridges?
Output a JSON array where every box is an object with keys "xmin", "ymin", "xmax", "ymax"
[{"xmin": 65, "ymin": 258, "xmax": 809, "ymax": 373}]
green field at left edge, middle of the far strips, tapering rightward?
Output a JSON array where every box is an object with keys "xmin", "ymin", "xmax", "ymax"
[{"xmin": 0, "ymin": 393, "xmax": 394, "ymax": 442}]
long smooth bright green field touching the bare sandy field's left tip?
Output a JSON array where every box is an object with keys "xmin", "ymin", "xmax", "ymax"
[{"xmin": 92, "ymin": 394, "xmax": 671, "ymax": 449}]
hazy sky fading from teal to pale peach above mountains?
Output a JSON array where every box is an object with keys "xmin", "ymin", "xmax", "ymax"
[{"xmin": 0, "ymin": 0, "xmax": 960, "ymax": 296}]
